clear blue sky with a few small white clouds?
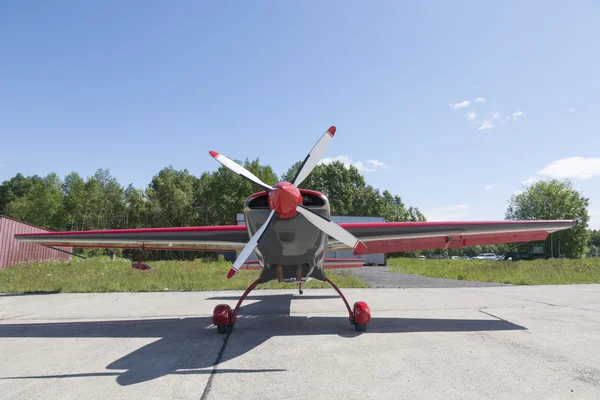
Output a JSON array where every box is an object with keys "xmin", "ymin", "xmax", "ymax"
[{"xmin": 0, "ymin": 0, "xmax": 600, "ymax": 229}]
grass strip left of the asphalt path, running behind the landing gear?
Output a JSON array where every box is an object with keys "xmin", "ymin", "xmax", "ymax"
[{"xmin": 0, "ymin": 257, "xmax": 368, "ymax": 293}]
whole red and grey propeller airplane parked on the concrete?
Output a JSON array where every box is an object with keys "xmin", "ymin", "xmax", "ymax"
[{"xmin": 15, "ymin": 126, "xmax": 575, "ymax": 333}]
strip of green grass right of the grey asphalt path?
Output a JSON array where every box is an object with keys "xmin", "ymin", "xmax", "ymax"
[{"xmin": 388, "ymin": 258, "xmax": 600, "ymax": 285}]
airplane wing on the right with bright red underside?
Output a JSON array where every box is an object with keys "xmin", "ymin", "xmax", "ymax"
[{"xmin": 328, "ymin": 220, "xmax": 575, "ymax": 254}]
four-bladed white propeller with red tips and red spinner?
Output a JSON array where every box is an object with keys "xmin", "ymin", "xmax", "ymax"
[{"xmin": 209, "ymin": 126, "xmax": 367, "ymax": 279}]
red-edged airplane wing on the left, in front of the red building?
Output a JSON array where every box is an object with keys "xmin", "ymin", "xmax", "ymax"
[{"xmin": 15, "ymin": 225, "xmax": 248, "ymax": 251}]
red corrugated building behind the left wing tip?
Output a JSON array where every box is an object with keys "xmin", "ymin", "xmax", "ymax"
[{"xmin": 0, "ymin": 215, "xmax": 72, "ymax": 268}]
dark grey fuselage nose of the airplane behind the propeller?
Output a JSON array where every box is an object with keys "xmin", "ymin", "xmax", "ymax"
[{"xmin": 244, "ymin": 189, "xmax": 329, "ymax": 283}]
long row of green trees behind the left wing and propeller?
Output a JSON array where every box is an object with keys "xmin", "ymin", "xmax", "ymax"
[{"xmin": 0, "ymin": 159, "xmax": 425, "ymax": 231}]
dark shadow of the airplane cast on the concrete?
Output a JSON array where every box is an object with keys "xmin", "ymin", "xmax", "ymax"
[{"xmin": 0, "ymin": 294, "xmax": 526, "ymax": 386}]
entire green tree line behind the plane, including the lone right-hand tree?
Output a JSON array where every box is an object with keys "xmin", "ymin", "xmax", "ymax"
[{"xmin": 0, "ymin": 159, "xmax": 600, "ymax": 257}]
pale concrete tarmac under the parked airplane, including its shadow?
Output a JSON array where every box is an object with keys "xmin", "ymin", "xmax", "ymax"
[{"xmin": 0, "ymin": 285, "xmax": 600, "ymax": 400}]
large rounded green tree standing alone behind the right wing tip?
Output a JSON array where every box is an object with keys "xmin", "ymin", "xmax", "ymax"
[{"xmin": 506, "ymin": 180, "xmax": 590, "ymax": 258}]
